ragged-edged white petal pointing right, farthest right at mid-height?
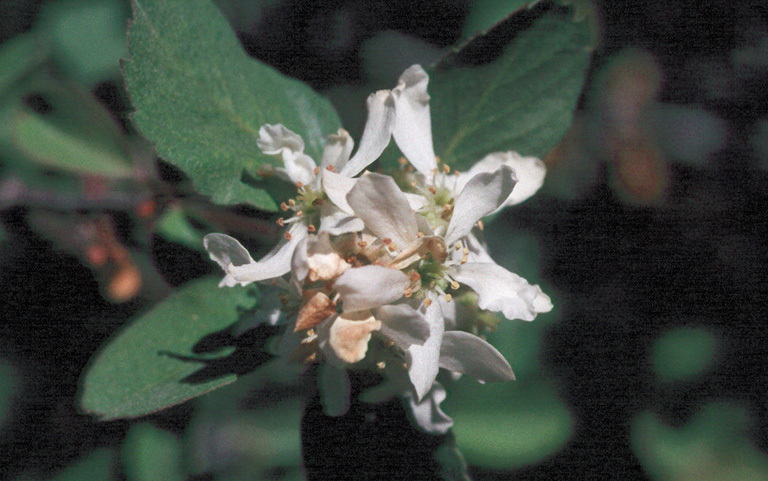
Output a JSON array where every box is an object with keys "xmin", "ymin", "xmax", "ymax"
[{"xmin": 449, "ymin": 262, "xmax": 552, "ymax": 321}]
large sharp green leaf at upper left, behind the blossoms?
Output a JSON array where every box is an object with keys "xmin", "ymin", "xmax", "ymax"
[{"xmin": 124, "ymin": 0, "xmax": 340, "ymax": 210}]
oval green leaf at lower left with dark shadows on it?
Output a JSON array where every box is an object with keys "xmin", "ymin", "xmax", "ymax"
[{"xmin": 80, "ymin": 278, "xmax": 255, "ymax": 420}]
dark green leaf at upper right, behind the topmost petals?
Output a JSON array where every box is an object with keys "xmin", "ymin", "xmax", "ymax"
[{"xmin": 429, "ymin": 3, "xmax": 592, "ymax": 170}]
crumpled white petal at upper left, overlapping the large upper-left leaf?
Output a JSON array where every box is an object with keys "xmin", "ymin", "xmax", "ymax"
[{"xmin": 256, "ymin": 124, "xmax": 315, "ymax": 185}]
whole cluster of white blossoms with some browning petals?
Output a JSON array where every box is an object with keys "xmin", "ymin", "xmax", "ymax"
[{"xmin": 205, "ymin": 65, "xmax": 552, "ymax": 432}]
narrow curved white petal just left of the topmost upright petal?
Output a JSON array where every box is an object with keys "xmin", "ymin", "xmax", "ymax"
[{"xmin": 341, "ymin": 90, "xmax": 395, "ymax": 177}]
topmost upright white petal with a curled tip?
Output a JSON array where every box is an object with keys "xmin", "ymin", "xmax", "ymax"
[{"xmin": 392, "ymin": 65, "xmax": 437, "ymax": 174}]
